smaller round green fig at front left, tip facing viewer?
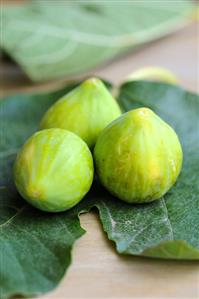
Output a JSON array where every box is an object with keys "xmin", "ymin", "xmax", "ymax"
[{"xmin": 14, "ymin": 129, "xmax": 94, "ymax": 212}]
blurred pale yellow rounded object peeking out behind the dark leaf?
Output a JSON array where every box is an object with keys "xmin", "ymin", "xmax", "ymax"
[{"xmin": 126, "ymin": 67, "xmax": 179, "ymax": 84}]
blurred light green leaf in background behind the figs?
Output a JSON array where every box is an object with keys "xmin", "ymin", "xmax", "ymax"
[{"xmin": 0, "ymin": 0, "xmax": 193, "ymax": 81}]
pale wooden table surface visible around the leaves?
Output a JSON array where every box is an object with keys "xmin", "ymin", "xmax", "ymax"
[{"xmin": 0, "ymin": 11, "xmax": 199, "ymax": 299}]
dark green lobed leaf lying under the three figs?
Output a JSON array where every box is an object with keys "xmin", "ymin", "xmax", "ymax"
[{"xmin": 0, "ymin": 82, "xmax": 199, "ymax": 298}]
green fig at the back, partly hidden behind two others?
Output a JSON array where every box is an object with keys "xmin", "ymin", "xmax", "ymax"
[{"xmin": 40, "ymin": 78, "xmax": 121, "ymax": 148}]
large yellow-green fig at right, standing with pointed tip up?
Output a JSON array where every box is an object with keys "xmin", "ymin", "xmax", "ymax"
[{"xmin": 94, "ymin": 108, "xmax": 183, "ymax": 203}]
